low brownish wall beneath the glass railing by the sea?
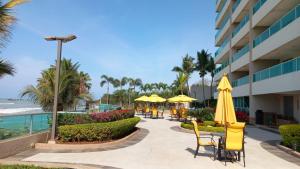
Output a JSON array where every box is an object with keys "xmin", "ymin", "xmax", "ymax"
[{"xmin": 0, "ymin": 131, "xmax": 49, "ymax": 159}]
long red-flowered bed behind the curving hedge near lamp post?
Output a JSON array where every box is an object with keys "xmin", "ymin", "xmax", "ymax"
[{"xmin": 58, "ymin": 110, "xmax": 134, "ymax": 126}]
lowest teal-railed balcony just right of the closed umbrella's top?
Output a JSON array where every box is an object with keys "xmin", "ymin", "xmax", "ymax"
[{"xmin": 232, "ymin": 75, "xmax": 250, "ymax": 97}]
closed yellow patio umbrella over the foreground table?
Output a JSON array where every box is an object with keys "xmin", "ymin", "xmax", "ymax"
[{"xmin": 215, "ymin": 74, "xmax": 236, "ymax": 125}]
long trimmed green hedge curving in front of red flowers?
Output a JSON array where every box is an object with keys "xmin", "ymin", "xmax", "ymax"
[{"xmin": 58, "ymin": 117, "xmax": 140, "ymax": 142}]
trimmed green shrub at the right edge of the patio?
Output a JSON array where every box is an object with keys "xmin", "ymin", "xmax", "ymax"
[{"xmin": 279, "ymin": 124, "xmax": 300, "ymax": 151}]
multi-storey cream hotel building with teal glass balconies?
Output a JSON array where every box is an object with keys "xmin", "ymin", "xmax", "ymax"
[{"xmin": 215, "ymin": 0, "xmax": 300, "ymax": 122}]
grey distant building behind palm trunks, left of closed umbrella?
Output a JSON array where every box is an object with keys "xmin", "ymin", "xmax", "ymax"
[{"xmin": 190, "ymin": 83, "xmax": 216, "ymax": 102}]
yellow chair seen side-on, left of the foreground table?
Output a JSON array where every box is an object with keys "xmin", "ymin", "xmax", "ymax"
[{"xmin": 192, "ymin": 120, "xmax": 217, "ymax": 160}]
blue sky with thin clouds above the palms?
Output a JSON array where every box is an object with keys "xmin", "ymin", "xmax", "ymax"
[{"xmin": 0, "ymin": 0, "xmax": 215, "ymax": 98}]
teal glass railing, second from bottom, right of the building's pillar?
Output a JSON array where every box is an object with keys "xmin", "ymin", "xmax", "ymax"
[{"xmin": 253, "ymin": 4, "xmax": 300, "ymax": 47}]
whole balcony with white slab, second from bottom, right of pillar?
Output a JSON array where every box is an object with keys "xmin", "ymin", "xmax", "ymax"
[{"xmin": 253, "ymin": 5, "xmax": 300, "ymax": 61}]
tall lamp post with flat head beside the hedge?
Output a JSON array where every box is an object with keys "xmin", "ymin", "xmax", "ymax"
[{"xmin": 45, "ymin": 35, "xmax": 76, "ymax": 144}]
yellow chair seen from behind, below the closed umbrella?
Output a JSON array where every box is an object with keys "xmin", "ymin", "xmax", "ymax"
[{"xmin": 224, "ymin": 122, "xmax": 246, "ymax": 167}]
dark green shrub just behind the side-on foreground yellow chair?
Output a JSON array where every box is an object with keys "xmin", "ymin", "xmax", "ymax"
[{"xmin": 188, "ymin": 107, "xmax": 215, "ymax": 122}]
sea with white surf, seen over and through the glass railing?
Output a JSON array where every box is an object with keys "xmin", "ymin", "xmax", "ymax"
[{"xmin": 0, "ymin": 99, "xmax": 51, "ymax": 140}]
